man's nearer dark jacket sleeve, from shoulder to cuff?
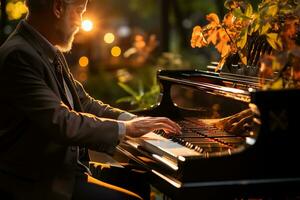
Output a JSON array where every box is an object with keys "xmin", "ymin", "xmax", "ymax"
[{"xmin": 0, "ymin": 51, "xmax": 119, "ymax": 151}]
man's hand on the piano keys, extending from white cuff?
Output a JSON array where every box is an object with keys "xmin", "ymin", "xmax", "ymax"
[{"xmin": 125, "ymin": 117, "xmax": 181, "ymax": 137}]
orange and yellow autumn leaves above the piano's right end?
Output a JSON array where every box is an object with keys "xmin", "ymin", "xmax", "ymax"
[{"xmin": 191, "ymin": 0, "xmax": 300, "ymax": 88}]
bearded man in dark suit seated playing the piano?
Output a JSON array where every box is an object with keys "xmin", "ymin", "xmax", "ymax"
[{"xmin": 0, "ymin": 0, "xmax": 180, "ymax": 199}]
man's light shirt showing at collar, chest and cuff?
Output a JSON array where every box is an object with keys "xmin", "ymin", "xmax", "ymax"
[{"xmin": 23, "ymin": 20, "xmax": 137, "ymax": 140}]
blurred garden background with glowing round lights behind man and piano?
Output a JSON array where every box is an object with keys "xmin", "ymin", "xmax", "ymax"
[{"xmin": 0, "ymin": 0, "xmax": 260, "ymax": 110}]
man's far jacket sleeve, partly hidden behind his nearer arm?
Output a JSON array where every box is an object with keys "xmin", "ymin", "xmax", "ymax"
[{"xmin": 71, "ymin": 75, "xmax": 125, "ymax": 119}]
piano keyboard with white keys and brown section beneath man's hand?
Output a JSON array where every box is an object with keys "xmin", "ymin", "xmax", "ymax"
[{"xmin": 127, "ymin": 119, "xmax": 244, "ymax": 167}]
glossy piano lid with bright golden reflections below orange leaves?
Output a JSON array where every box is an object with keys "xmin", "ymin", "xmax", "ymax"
[{"xmin": 157, "ymin": 70, "xmax": 260, "ymax": 103}]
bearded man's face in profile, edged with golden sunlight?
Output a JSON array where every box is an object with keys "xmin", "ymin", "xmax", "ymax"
[{"xmin": 56, "ymin": 0, "xmax": 87, "ymax": 52}]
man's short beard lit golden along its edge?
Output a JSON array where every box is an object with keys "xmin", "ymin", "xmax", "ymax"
[{"xmin": 56, "ymin": 20, "xmax": 79, "ymax": 52}]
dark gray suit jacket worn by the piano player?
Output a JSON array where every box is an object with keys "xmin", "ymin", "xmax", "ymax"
[{"xmin": 0, "ymin": 22, "xmax": 124, "ymax": 199}]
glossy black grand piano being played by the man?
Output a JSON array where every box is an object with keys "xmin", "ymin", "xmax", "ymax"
[{"xmin": 119, "ymin": 70, "xmax": 300, "ymax": 199}]
